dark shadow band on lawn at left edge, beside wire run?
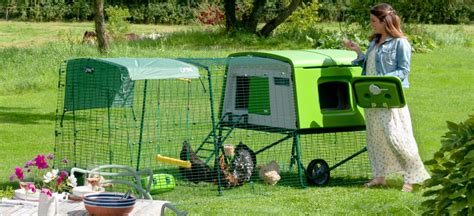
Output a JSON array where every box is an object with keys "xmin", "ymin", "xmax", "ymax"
[{"xmin": 0, "ymin": 107, "xmax": 55, "ymax": 124}]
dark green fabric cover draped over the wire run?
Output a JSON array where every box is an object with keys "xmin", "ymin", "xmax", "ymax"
[{"xmin": 64, "ymin": 58, "xmax": 199, "ymax": 111}]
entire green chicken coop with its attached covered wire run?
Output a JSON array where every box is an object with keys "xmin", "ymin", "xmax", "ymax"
[{"xmin": 55, "ymin": 50, "xmax": 404, "ymax": 192}]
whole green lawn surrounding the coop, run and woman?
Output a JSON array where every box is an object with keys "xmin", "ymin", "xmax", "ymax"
[{"xmin": 0, "ymin": 21, "xmax": 474, "ymax": 215}]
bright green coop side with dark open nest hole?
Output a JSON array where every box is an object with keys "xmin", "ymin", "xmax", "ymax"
[{"xmin": 295, "ymin": 67, "xmax": 365, "ymax": 129}]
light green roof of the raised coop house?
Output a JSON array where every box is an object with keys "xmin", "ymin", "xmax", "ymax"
[{"xmin": 230, "ymin": 49, "xmax": 357, "ymax": 68}]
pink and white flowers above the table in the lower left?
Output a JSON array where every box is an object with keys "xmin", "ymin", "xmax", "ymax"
[{"xmin": 10, "ymin": 153, "xmax": 77, "ymax": 197}]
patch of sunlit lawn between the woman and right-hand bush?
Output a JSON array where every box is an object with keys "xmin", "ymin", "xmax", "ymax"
[{"xmin": 407, "ymin": 47, "xmax": 474, "ymax": 160}]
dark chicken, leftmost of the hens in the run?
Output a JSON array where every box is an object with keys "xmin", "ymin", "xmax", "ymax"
[{"xmin": 179, "ymin": 141, "xmax": 216, "ymax": 184}]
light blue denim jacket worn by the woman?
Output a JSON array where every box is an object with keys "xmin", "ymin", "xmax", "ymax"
[{"xmin": 352, "ymin": 37, "xmax": 411, "ymax": 88}]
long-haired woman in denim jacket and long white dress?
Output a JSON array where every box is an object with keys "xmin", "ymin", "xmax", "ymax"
[{"xmin": 343, "ymin": 4, "xmax": 430, "ymax": 192}]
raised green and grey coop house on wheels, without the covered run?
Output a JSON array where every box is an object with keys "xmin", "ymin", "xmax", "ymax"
[{"xmin": 220, "ymin": 50, "xmax": 404, "ymax": 185}]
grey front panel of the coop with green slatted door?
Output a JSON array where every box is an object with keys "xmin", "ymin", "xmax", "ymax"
[{"xmin": 221, "ymin": 57, "xmax": 296, "ymax": 129}]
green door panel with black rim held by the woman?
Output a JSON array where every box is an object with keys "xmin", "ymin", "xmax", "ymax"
[{"xmin": 352, "ymin": 76, "xmax": 405, "ymax": 108}]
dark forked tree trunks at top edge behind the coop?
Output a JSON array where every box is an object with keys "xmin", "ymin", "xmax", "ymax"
[{"xmin": 224, "ymin": 0, "xmax": 302, "ymax": 37}]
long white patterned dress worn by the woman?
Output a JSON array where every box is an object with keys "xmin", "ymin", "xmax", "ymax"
[{"xmin": 364, "ymin": 47, "xmax": 430, "ymax": 184}]
